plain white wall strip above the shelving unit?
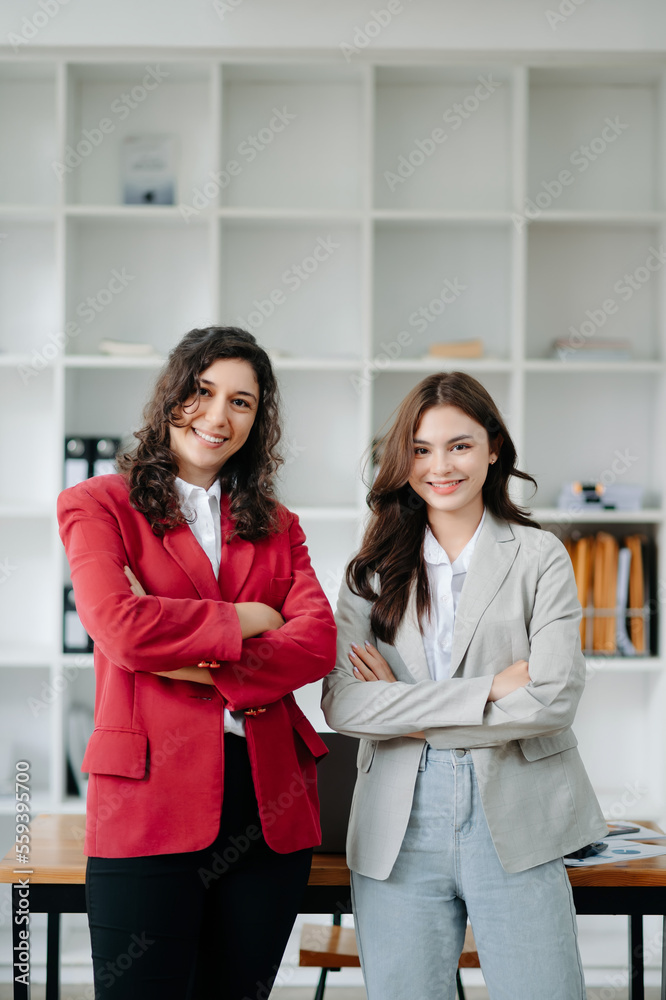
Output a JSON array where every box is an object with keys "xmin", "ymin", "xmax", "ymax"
[{"xmin": 0, "ymin": 0, "xmax": 666, "ymax": 52}]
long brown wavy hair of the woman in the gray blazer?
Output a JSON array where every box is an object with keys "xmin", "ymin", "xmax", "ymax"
[{"xmin": 347, "ymin": 372, "xmax": 540, "ymax": 643}]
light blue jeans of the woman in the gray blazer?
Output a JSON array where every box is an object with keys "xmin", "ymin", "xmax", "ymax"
[{"xmin": 352, "ymin": 747, "xmax": 586, "ymax": 1000}]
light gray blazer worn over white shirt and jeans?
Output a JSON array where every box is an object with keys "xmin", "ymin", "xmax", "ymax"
[{"xmin": 322, "ymin": 511, "xmax": 608, "ymax": 879}]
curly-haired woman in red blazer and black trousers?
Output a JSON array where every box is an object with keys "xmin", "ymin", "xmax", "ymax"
[{"xmin": 58, "ymin": 327, "xmax": 335, "ymax": 1000}]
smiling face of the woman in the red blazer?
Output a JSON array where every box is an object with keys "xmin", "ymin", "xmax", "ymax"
[{"xmin": 170, "ymin": 358, "xmax": 259, "ymax": 489}]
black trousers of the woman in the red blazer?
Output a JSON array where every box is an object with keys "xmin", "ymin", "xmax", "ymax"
[{"xmin": 86, "ymin": 734, "xmax": 312, "ymax": 1000}]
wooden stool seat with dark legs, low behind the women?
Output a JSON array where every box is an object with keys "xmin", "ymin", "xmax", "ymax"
[{"xmin": 298, "ymin": 913, "xmax": 481, "ymax": 1000}]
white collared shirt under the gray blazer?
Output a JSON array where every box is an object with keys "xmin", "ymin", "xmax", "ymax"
[{"xmin": 422, "ymin": 507, "xmax": 486, "ymax": 681}]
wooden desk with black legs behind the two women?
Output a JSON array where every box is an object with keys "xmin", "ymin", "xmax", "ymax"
[{"xmin": 0, "ymin": 815, "xmax": 666, "ymax": 1000}]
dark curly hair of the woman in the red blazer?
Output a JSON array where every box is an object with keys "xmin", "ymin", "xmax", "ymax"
[{"xmin": 118, "ymin": 326, "xmax": 283, "ymax": 540}]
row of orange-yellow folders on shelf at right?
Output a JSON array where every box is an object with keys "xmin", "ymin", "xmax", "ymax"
[{"xmin": 564, "ymin": 531, "xmax": 656, "ymax": 656}]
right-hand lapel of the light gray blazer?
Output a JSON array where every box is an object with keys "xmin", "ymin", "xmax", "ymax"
[{"xmin": 451, "ymin": 511, "xmax": 520, "ymax": 676}]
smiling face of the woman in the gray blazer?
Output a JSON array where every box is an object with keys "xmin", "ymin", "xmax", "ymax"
[{"xmin": 409, "ymin": 405, "xmax": 497, "ymax": 523}]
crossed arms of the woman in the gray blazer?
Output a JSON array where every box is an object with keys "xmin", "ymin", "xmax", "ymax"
[{"xmin": 322, "ymin": 531, "xmax": 585, "ymax": 747}]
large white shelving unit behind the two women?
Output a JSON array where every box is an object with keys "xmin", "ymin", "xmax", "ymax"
[{"xmin": 0, "ymin": 50, "xmax": 666, "ymax": 852}]
